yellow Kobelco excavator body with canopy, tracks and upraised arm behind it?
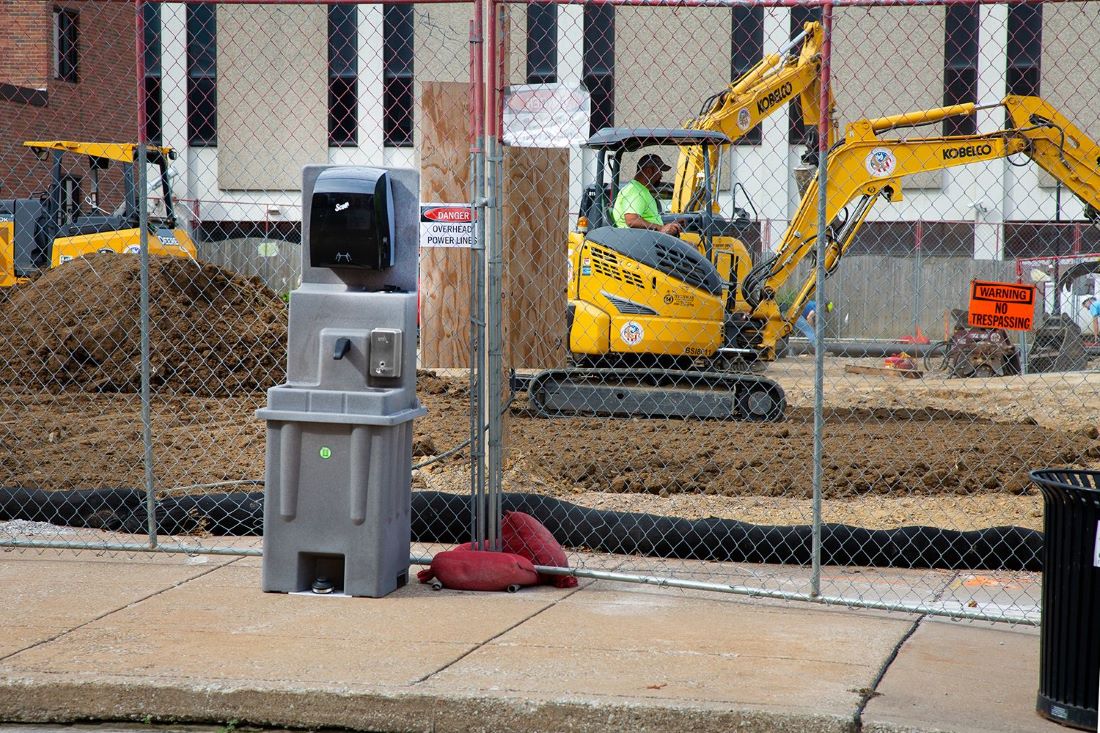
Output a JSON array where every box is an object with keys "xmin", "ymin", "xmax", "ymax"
[{"xmin": 514, "ymin": 22, "xmax": 832, "ymax": 419}]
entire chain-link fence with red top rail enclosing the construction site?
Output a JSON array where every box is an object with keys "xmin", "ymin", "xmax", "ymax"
[{"xmin": 0, "ymin": 1, "xmax": 1100, "ymax": 623}]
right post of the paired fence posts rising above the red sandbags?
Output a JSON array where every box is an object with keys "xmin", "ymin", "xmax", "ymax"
[{"xmin": 485, "ymin": 0, "xmax": 505, "ymax": 549}]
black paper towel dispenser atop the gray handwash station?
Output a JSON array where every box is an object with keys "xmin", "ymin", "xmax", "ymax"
[{"xmin": 309, "ymin": 167, "xmax": 395, "ymax": 270}]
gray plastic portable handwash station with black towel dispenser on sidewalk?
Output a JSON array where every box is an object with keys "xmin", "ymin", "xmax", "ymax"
[{"xmin": 256, "ymin": 165, "xmax": 426, "ymax": 598}]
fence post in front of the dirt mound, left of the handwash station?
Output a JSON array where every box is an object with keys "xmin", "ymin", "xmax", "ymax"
[{"xmin": 133, "ymin": 0, "xmax": 157, "ymax": 548}]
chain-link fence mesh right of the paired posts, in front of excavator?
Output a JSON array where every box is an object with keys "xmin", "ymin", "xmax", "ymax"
[{"xmin": 495, "ymin": 2, "xmax": 1100, "ymax": 617}]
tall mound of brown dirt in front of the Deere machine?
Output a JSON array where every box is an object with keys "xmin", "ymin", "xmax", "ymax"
[{"xmin": 0, "ymin": 254, "xmax": 287, "ymax": 396}]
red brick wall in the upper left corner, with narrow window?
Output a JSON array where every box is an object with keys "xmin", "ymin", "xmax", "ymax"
[{"xmin": 0, "ymin": 0, "xmax": 138, "ymax": 198}]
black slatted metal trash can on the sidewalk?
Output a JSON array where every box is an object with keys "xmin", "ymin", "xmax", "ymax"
[{"xmin": 1031, "ymin": 469, "xmax": 1100, "ymax": 731}]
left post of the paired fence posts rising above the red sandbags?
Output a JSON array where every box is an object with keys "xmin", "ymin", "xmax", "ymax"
[{"xmin": 470, "ymin": 0, "xmax": 487, "ymax": 549}]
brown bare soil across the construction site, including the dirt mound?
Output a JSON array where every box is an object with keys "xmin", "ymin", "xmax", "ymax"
[{"xmin": 0, "ymin": 256, "xmax": 1100, "ymax": 529}]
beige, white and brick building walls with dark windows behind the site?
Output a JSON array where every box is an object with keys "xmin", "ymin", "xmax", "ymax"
[{"xmin": 0, "ymin": 0, "xmax": 1100, "ymax": 259}]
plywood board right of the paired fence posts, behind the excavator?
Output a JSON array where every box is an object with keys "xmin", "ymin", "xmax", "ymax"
[{"xmin": 502, "ymin": 147, "xmax": 569, "ymax": 369}]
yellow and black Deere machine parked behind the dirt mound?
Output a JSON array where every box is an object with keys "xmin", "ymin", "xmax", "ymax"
[{"xmin": 0, "ymin": 140, "xmax": 195, "ymax": 288}]
